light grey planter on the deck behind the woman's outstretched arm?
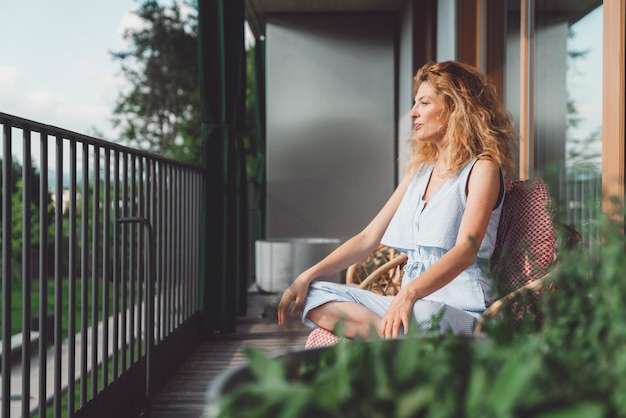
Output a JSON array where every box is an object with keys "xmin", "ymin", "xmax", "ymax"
[{"xmin": 255, "ymin": 238, "xmax": 341, "ymax": 293}]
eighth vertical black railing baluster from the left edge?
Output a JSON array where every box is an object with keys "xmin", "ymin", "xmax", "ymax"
[{"xmin": 102, "ymin": 148, "xmax": 111, "ymax": 388}]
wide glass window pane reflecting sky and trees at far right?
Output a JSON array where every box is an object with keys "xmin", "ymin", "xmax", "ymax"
[{"xmin": 533, "ymin": 0, "xmax": 602, "ymax": 245}]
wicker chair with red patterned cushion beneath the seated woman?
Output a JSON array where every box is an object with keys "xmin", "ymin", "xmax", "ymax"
[{"xmin": 305, "ymin": 179, "xmax": 580, "ymax": 348}]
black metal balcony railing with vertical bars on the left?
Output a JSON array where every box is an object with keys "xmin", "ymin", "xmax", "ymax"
[{"xmin": 0, "ymin": 113, "xmax": 203, "ymax": 418}]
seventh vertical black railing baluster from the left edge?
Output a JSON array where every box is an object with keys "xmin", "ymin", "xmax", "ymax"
[{"xmin": 90, "ymin": 145, "xmax": 100, "ymax": 399}]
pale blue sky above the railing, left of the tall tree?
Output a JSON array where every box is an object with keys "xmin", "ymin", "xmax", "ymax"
[{"xmin": 0, "ymin": 0, "xmax": 140, "ymax": 139}]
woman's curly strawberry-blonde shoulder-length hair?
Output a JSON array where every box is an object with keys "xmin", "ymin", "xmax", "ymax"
[{"xmin": 407, "ymin": 61, "xmax": 518, "ymax": 174}]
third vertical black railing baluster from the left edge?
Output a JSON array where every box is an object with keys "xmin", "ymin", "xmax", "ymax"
[{"xmin": 38, "ymin": 131, "xmax": 51, "ymax": 416}]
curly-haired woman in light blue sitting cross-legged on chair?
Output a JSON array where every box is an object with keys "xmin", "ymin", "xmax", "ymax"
[{"xmin": 278, "ymin": 61, "xmax": 516, "ymax": 338}]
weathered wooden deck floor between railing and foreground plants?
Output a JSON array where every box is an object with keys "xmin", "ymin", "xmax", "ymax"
[{"xmin": 150, "ymin": 292, "xmax": 310, "ymax": 418}]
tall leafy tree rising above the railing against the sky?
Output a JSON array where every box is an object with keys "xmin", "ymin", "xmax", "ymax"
[{"xmin": 112, "ymin": 0, "xmax": 202, "ymax": 163}]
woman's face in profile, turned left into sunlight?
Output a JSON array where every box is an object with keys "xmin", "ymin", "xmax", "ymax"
[{"xmin": 411, "ymin": 82, "xmax": 445, "ymax": 144}]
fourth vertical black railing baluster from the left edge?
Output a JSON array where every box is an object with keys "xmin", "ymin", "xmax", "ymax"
[{"xmin": 54, "ymin": 133, "xmax": 63, "ymax": 418}]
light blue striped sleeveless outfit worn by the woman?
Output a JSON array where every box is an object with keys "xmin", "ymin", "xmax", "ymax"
[{"xmin": 302, "ymin": 158, "xmax": 504, "ymax": 334}]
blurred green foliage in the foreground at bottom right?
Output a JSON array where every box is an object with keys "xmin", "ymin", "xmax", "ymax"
[{"xmin": 214, "ymin": 220, "xmax": 626, "ymax": 418}]
